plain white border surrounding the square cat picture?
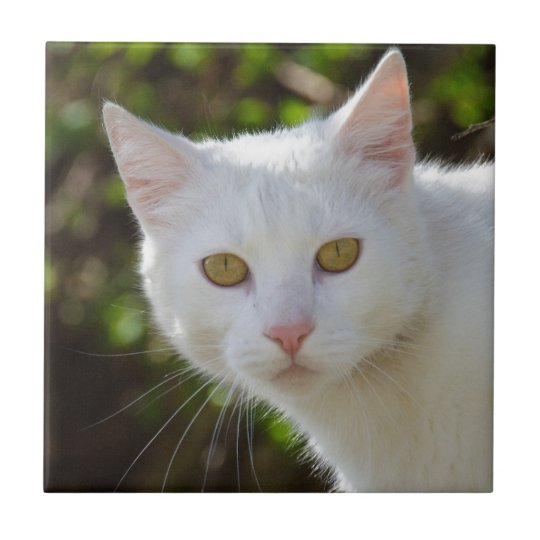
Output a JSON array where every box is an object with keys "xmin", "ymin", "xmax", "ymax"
[{"xmin": 4, "ymin": 0, "xmax": 540, "ymax": 540}]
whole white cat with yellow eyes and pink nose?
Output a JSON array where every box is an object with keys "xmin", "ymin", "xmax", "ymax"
[{"xmin": 103, "ymin": 50, "xmax": 493, "ymax": 491}]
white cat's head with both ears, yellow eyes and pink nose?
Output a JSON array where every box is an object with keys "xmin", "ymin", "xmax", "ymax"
[{"xmin": 104, "ymin": 51, "xmax": 424, "ymax": 399}]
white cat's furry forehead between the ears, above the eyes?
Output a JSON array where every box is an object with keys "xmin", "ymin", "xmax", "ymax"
[{"xmin": 181, "ymin": 126, "xmax": 380, "ymax": 258}]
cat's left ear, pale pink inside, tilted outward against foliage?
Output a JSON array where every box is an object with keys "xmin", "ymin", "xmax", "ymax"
[{"xmin": 103, "ymin": 103, "xmax": 192, "ymax": 230}]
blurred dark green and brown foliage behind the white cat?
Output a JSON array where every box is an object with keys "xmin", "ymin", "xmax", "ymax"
[{"xmin": 44, "ymin": 43, "xmax": 495, "ymax": 492}]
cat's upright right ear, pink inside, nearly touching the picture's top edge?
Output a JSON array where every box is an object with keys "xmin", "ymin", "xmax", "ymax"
[{"xmin": 336, "ymin": 49, "xmax": 415, "ymax": 187}]
